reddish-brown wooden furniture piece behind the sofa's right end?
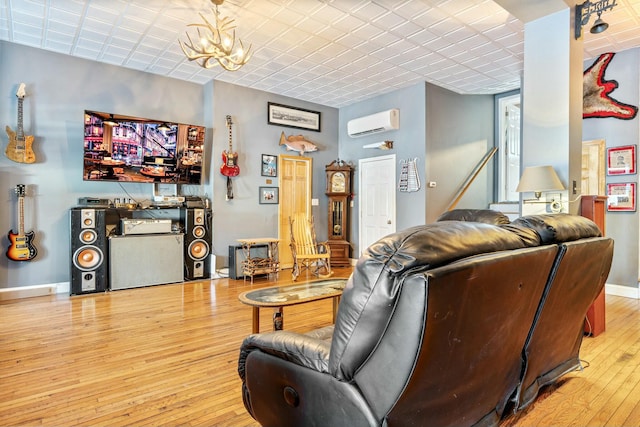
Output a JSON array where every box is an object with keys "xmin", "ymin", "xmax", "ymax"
[{"xmin": 580, "ymin": 196, "xmax": 607, "ymax": 337}]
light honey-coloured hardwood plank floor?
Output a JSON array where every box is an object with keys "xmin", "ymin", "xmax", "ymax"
[{"xmin": 0, "ymin": 269, "xmax": 640, "ymax": 426}]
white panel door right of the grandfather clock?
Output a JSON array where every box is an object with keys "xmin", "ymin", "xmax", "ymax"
[{"xmin": 358, "ymin": 154, "xmax": 396, "ymax": 257}]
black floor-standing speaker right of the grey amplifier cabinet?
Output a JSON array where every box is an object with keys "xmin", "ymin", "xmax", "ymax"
[{"xmin": 184, "ymin": 208, "xmax": 213, "ymax": 280}]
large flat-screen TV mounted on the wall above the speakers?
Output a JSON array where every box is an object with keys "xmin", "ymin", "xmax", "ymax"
[{"xmin": 83, "ymin": 110, "xmax": 205, "ymax": 184}]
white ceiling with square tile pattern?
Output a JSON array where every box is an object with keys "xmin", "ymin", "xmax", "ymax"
[{"xmin": 0, "ymin": 0, "xmax": 640, "ymax": 107}]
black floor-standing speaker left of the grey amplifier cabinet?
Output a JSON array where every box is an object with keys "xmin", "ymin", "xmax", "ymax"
[{"xmin": 70, "ymin": 208, "xmax": 109, "ymax": 295}]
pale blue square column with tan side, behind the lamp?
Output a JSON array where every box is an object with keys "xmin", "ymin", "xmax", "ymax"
[{"xmin": 498, "ymin": 0, "xmax": 583, "ymax": 214}]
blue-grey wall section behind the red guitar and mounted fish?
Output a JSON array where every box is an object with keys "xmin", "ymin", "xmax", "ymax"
[{"xmin": 211, "ymin": 81, "xmax": 338, "ymax": 260}]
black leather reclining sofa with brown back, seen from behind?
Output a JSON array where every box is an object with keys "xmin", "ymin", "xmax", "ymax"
[{"xmin": 238, "ymin": 211, "xmax": 613, "ymax": 427}]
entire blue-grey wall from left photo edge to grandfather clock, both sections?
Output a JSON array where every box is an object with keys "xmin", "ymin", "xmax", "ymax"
[{"xmin": 0, "ymin": 42, "xmax": 338, "ymax": 288}]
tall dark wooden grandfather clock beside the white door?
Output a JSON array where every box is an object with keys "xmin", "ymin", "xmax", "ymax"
[{"xmin": 325, "ymin": 160, "xmax": 352, "ymax": 267}]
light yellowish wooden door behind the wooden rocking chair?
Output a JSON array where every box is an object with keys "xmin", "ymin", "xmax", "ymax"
[{"xmin": 278, "ymin": 155, "xmax": 313, "ymax": 268}]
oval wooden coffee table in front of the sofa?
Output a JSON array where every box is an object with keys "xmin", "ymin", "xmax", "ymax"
[{"xmin": 238, "ymin": 279, "xmax": 347, "ymax": 334}]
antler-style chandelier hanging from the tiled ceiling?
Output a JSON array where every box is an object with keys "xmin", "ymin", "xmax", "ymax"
[{"xmin": 179, "ymin": 0, "xmax": 251, "ymax": 71}]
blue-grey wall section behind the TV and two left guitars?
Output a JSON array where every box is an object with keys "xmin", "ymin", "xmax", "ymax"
[{"xmin": 0, "ymin": 41, "xmax": 205, "ymax": 288}]
